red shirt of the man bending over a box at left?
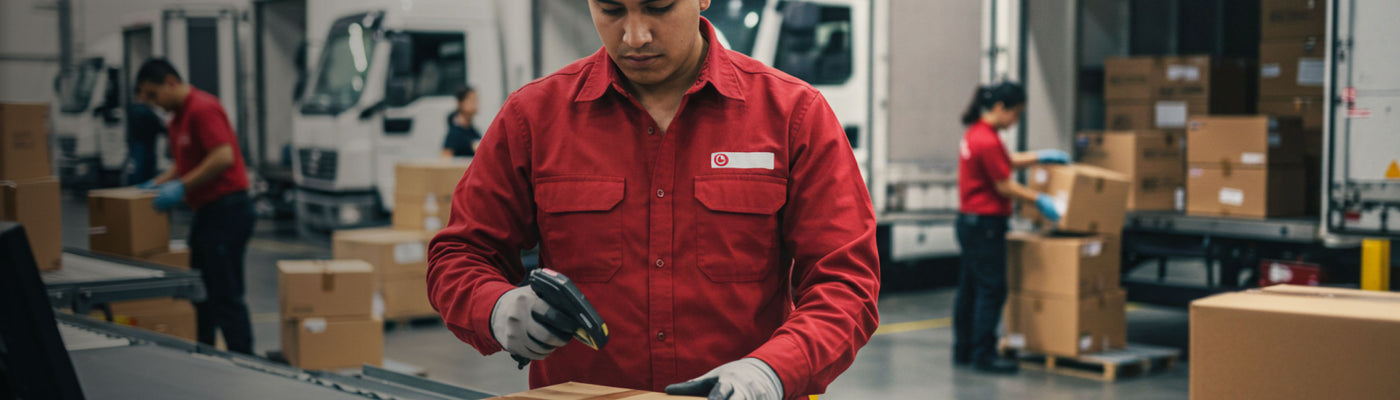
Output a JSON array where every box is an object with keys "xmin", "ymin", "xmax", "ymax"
[{"xmin": 169, "ymin": 87, "xmax": 248, "ymax": 208}]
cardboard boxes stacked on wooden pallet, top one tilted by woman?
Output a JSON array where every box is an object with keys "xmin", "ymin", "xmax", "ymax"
[{"xmin": 1005, "ymin": 165, "xmax": 1130, "ymax": 357}]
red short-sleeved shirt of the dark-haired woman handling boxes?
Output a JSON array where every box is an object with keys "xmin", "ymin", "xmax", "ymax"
[{"xmin": 958, "ymin": 120, "xmax": 1011, "ymax": 217}]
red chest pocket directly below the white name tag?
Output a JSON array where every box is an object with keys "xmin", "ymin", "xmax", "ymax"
[{"xmin": 696, "ymin": 175, "xmax": 787, "ymax": 283}]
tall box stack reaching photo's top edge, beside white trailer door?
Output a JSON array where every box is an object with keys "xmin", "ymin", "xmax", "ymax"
[{"xmin": 1259, "ymin": 0, "xmax": 1329, "ymax": 214}]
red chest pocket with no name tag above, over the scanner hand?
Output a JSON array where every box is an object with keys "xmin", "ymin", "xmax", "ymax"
[{"xmin": 535, "ymin": 176, "xmax": 626, "ymax": 283}]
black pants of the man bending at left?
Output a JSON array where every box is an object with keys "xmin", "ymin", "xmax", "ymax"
[{"xmin": 189, "ymin": 192, "xmax": 256, "ymax": 354}]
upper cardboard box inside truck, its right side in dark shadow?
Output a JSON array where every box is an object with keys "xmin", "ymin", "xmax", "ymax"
[{"xmin": 1155, "ymin": 56, "xmax": 1254, "ymax": 114}]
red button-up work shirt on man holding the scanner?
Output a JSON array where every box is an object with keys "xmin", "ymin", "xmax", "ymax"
[{"xmin": 427, "ymin": 21, "xmax": 879, "ymax": 399}]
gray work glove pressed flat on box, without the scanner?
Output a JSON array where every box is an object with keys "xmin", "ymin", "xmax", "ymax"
[{"xmin": 666, "ymin": 358, "xmax": 783, "ymax": 400}]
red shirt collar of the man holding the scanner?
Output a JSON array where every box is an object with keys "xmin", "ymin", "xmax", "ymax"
[{"xmin": 574, "ymin": 17, "xmax": 743, "ymax": 102}]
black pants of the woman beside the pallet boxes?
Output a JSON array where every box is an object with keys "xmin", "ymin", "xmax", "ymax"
[{"xmin": 953, "ymin": 214, "xmax": 1007, "ymax": 361}]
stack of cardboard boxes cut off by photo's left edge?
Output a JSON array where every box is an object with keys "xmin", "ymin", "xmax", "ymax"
[{"xmin": 0, "ymin": 103, "xmax": 63, "ymax": 271}]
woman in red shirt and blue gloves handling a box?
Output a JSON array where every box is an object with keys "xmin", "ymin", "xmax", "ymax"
[{"xmin": 953, "ymin": 83, "xmax": 1070, "ymax": 373}]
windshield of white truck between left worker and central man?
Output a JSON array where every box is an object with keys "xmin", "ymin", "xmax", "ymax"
[{"xmin": 301, "ymin": 14, "xmax": 378, "ymax": 115}]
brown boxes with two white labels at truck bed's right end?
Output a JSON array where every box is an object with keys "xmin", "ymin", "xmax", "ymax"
[{"xmin": 1186, "ymin": 116, "xmax": 1308, "ymax": 218}]
